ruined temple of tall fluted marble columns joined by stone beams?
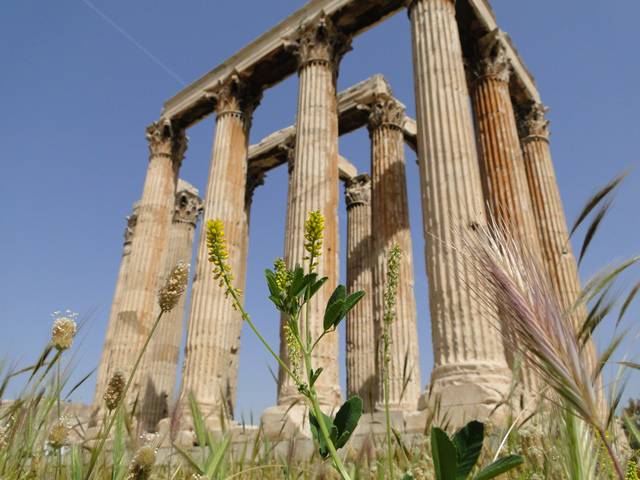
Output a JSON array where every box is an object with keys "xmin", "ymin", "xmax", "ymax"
[{"xmin": 95, "ymin": 0, "xmax": 592, "ymax": 435}]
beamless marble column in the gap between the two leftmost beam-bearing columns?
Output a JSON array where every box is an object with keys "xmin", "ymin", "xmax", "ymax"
[{"xmin": 140, "ymin": 180, "xmax": 202, "ymax": 431}]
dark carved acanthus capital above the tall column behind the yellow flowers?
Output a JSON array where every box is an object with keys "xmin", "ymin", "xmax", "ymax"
[{"xmin": 285, "ymin": 12, "xmax": 351, "ymax": 74}]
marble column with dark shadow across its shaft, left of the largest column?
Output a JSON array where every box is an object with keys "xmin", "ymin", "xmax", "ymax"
[{"xmin": 368, "ymin": 95, "xmax": 421, "ymax": 411}]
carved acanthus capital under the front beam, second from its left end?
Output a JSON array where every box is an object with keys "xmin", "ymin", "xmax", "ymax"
[{"xmin": 205, "ymin": 71, "xmax": 262, "ymax": 121}]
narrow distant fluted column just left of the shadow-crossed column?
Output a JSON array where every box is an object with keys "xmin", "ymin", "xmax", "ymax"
[{"xmin": 345, "ymin": 174, "xmax": 377, "ymax": 412}]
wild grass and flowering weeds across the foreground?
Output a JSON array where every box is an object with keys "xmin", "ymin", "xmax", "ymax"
[{"xmin": 0, "ymin": 179, "xmax": 640, "ymax": 480}]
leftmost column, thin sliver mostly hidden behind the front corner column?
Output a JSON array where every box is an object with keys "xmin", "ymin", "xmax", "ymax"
[{"xmin": 93, "ymin": 203, "xmax": 138, "ymax": 414}]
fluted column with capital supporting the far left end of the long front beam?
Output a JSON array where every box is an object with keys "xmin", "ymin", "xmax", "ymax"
[{"xmin": 106, "ymin": 121, "xmax": 186, "ymax": 400}]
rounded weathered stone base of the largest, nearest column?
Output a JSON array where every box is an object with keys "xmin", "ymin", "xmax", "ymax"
[{"xmin": 418, "ymin": 362, "xmax": 512, "ymax": 428}]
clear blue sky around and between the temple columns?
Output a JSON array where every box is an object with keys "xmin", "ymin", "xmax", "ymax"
[{"xmin": 0, "ymin": 0, "xmax": 640, "ymax": 417}]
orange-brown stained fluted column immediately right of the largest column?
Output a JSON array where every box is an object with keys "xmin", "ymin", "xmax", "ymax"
[{"xmin": 471, "ymin": 30, "xmax": 542, "ymax": 391}]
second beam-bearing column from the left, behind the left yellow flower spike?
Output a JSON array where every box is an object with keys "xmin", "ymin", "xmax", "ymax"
[{"xmin": 181, "ymin": 74, "xmax": 259, "ymax": 427}]
